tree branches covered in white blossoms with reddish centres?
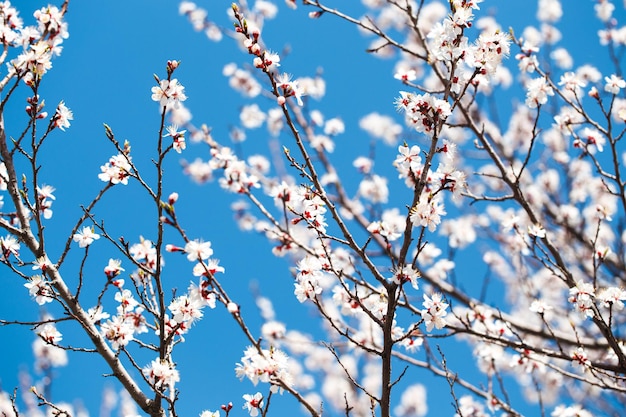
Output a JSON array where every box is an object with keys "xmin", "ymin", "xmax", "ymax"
[{"xmin": 0, "ymin": 0, "xmax": 626, "ymax": 417}]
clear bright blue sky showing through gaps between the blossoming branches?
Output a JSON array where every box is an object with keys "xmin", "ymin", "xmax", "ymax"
[{"xmin": 0, "ymin": 0, "xmax": 624, "ymax": 415}]
